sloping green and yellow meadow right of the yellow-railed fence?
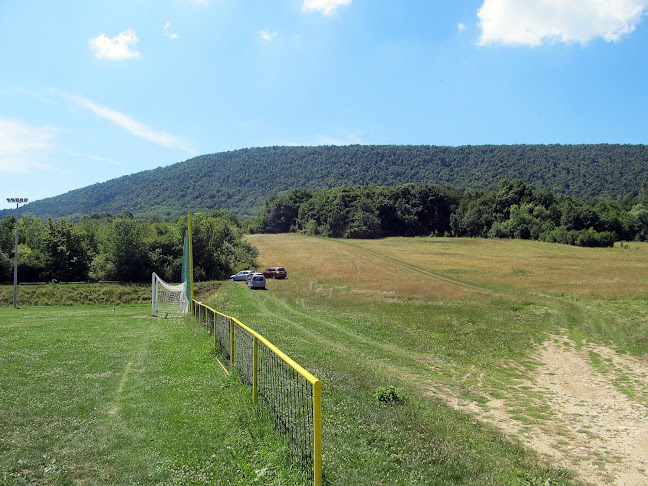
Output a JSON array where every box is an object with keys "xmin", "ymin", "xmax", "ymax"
[{"xmin": 207, "ymin": 235, "xmax": 648, "ymax": 485}]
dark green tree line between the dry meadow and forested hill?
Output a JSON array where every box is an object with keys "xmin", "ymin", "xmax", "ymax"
[{"xmin": 253, "ymin": 179, "xmax": 648, "ymax": 246}]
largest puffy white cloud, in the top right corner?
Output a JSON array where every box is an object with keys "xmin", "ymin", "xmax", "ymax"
[{"xmin": 477, "ymin": 0, "xmax": 648, "ymax": 47}]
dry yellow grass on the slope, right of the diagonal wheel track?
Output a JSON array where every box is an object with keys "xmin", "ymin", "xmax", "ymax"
[{"xmin": 356, "ymin": 238, "xmax": 648, "ymax": 298}]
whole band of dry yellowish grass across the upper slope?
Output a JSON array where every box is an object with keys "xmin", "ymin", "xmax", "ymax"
[{"xmin": 249, "ymin": 234, "xmax": 648, "ymax": 300}]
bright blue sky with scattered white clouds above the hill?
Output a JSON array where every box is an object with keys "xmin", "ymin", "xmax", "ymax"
[{"xmin": 0, "ymin": 0, "xmax": 648, "ymax": 208}]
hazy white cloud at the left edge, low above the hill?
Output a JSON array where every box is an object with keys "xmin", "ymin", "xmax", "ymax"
[{"xmin": 0, "ymin": 118, "xmax": 61, "ymax": 174}]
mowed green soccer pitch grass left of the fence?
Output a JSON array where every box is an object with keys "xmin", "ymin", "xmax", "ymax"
[{"xmin": 0, "ymin": 306, "xmax": 305, "ymax": 485}]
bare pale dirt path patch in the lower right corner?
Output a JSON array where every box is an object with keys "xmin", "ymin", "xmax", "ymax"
[{"xmin": 446, "ymin": 336, "xmax": 648, "ymax": 486}]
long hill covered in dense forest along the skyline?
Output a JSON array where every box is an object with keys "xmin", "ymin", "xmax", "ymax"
[{"xmin": 5, "ymin": 144, "xmax": 648, "ymax": 218}]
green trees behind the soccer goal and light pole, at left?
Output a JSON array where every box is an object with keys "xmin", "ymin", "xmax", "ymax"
[{"xmin": 0, "ymin": 212, "xmax": 258, "ymax": 282}]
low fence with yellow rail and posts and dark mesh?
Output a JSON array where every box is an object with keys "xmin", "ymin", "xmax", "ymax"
[{"xmin": 192, "ymin": 300, "xmax": 322, "ymax": 486}]
